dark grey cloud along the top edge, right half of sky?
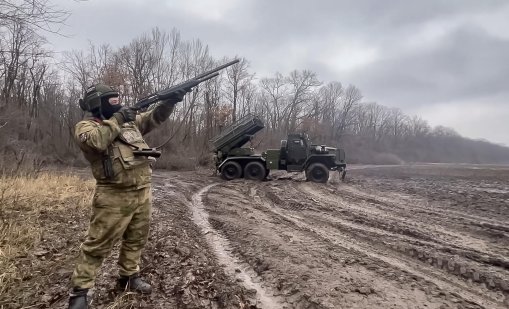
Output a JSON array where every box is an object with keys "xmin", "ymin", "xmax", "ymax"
[{"xmin": 240, "ymin": 0, "xmax": 507, "ymax": 40}]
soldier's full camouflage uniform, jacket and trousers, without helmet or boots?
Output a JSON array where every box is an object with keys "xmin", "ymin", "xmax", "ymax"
[{"xmin": 72, "ymin": 103, "xmax": 174, "ymax": 288}]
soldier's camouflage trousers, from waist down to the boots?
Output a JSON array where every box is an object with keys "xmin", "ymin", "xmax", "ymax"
[{"xmin": 72, "ymin": 187, "xmax": 152, "ymax": 288}]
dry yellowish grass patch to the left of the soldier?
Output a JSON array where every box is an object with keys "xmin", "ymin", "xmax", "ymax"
[{"xmin": 0, "ymin": 172, "xmax": 95, "ymax": 308}]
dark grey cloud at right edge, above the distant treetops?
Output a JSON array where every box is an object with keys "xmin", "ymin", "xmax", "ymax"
[{"xmin": 350, "ymin": 26, "xmax": 509, "ymax": 105}]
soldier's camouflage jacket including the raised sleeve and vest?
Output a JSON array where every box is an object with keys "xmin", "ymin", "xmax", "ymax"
[{"xmin": 74, "ymin": 104, "xmax": 174, "ymax": 190}]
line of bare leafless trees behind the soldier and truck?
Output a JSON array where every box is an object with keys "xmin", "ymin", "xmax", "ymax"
[{"xmin": 0, "ymin": 0, "xmax": 509, "ymax": 168}]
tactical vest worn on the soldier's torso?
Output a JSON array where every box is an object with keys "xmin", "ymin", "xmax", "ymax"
[{"xmin": 85, "ymin": 122, "xmax": 152, "ymax": 189}]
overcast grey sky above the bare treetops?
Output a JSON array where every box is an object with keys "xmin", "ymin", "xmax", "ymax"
[{"xmin": 46, "ymin": 0, "xmax": 509, "ymax": 146}]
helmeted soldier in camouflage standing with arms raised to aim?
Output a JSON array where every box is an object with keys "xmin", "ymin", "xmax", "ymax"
[{"xmin": 69, "ymin": 84, "xmax": 190, "ymax": 309}]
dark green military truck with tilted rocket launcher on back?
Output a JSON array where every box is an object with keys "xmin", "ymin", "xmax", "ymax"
[{"xmin": 211, "ymin": 114, "xmax": 346, "ymax": 183}]
